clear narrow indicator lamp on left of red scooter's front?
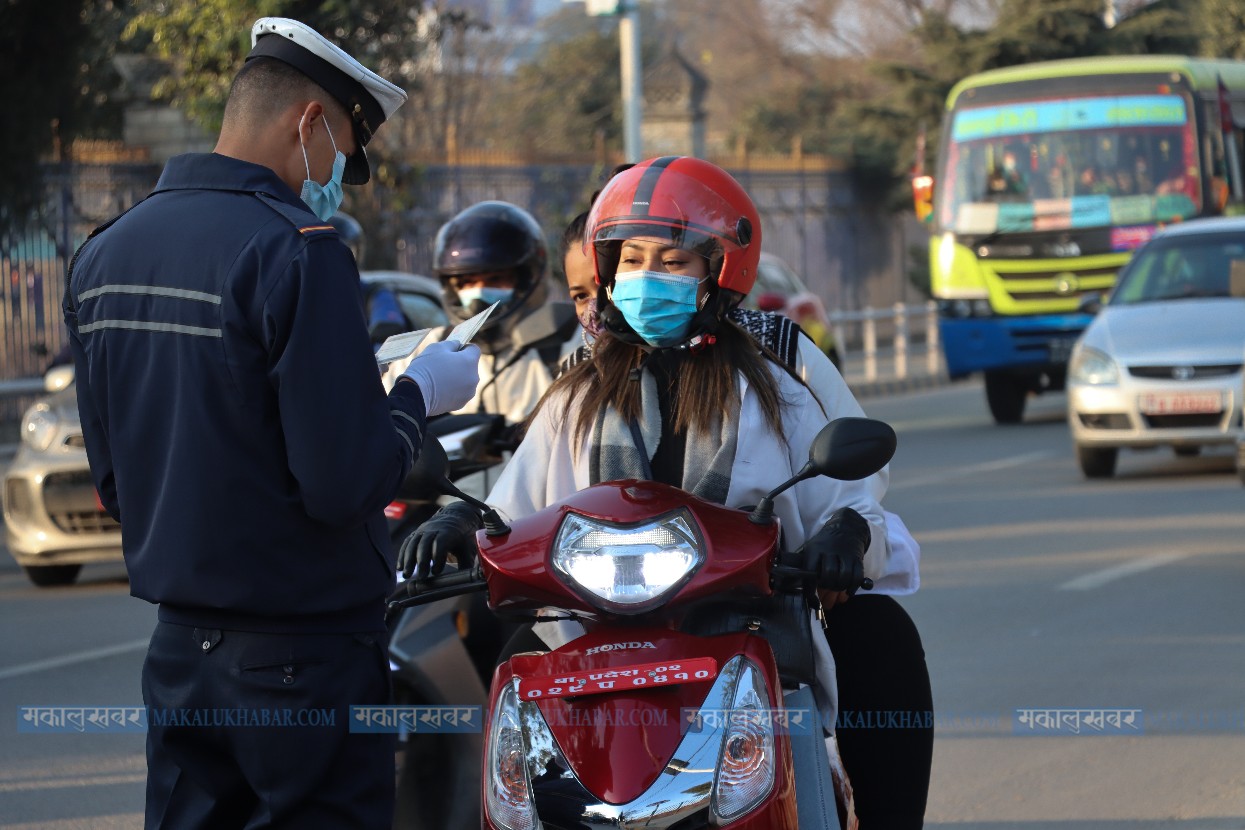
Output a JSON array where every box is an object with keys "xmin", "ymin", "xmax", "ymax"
[{"xmin": 484, "ymin": 683, "xmax": 540, "ymax": 830}]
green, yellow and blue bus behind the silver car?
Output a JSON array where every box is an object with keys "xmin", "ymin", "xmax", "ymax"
[{"xmin": 913, "ymin": 56, "xmax": 1245, "ymax": 423}]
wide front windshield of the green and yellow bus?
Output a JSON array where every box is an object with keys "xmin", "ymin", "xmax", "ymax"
[{"xmin": 937, "ymin": 92, "xmax": 1201, "ymax": 235}]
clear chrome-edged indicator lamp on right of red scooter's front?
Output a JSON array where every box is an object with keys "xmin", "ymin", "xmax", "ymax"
[{"xmin": 713, "ymin": 661, "xmax": 776, "ymax": 821}]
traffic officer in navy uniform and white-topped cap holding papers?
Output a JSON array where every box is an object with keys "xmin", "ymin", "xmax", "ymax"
[{"xmin": 65, "ymin": 17, "xmax": 479, "ymax": 830}]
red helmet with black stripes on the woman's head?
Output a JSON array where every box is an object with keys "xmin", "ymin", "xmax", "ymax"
[{"xmin": 584, "ymin": 156, "xmax": 761, "ymax": 307}]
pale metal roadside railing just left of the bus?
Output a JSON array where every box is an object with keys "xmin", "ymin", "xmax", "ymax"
[{"xmin": 829, "ymin": 300, "xmax": 942, "ymax": 381}]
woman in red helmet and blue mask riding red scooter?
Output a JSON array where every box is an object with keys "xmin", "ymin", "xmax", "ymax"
[{"xmin": 400, "ymin": 157, "xmax": 931, "ymax": 826}]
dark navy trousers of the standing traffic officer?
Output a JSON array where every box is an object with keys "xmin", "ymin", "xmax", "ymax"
[{"xmin": 142, "ymin": 621, "xmax": 396, "ymax": 830}]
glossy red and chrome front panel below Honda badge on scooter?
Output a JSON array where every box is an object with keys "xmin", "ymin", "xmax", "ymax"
[{"xmin": 484, "ymin": 627, "xmax": 798, "ymax": 830}]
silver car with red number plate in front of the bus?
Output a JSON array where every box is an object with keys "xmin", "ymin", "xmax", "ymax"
[{"xmin": 1067, "ymin": 217, "xmax": 1245, "ymax": 478}]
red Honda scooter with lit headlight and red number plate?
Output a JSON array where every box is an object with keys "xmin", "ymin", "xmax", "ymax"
[{"xmin": 391, "ymin": 418, "xmax": 895, "ymax": 830}]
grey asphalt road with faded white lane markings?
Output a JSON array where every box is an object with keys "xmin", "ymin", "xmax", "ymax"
[{"xmin": 0, "ymin": 385, "xmax": 1245, "ymax": 830}]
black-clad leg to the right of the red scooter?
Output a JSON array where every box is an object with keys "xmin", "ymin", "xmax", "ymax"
[{"xmin": 825, "ymin": 594, "xmax": 934, "ymax": 830}]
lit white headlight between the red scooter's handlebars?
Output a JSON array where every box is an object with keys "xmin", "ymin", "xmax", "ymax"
[{"xmin": 553, "ymin": 508, "xmax": 705, "ymax": 613}]
